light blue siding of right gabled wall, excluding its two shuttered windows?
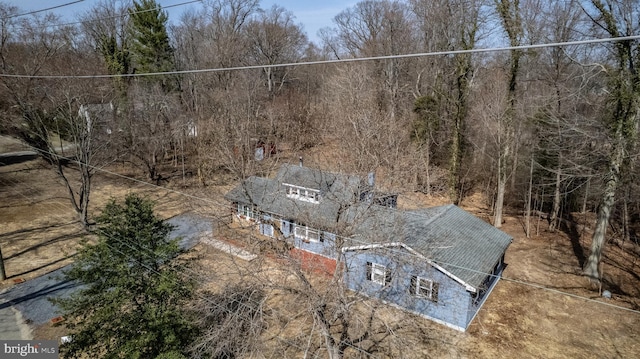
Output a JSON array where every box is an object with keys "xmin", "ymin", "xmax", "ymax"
[{"xmin": 344, "ymin": 249, "xmax": 473, "ymax": 330}]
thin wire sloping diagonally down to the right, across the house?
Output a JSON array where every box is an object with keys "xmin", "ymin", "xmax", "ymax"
[{"xmin": 18, "ymin": 149, "xmax": 640, "ymax": 314}]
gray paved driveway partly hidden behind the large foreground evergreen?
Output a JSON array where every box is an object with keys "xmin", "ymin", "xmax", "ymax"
[{"xmin": 0, "ymin": 214, "xmax": 212, "ymax": 339}]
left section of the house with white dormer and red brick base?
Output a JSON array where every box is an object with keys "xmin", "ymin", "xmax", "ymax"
[{"xmin": 225, "ymin": 164, "xmax": 372, "ymax": 271}]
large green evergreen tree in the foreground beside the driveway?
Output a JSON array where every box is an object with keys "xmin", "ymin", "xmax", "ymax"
[{"xmin": 56, "ymin": 195, "xmax": 196, "ymax": 358}]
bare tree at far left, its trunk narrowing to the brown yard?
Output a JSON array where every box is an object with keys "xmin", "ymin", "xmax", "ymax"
[{"xmin": 0, "ymin": 7, "xmax": 114, "ymax": 228}]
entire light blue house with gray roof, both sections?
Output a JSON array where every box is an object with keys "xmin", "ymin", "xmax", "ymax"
[{"xmin": 225, "ymin": 165, "xmax": 512, "ymax": 331}]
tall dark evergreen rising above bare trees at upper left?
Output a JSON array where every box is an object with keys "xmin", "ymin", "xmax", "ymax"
[{"xmin": 129, "ymin": 0, "xmax": 175, "ymax": 90}]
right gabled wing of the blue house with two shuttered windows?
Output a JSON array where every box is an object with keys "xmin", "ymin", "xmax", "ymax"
[{"xmin": 341, "ymin": 204, "xmax": 512, "ymax": 331}]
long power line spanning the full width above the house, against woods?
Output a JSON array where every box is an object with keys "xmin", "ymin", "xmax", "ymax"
[{"xmin": 0, "ymin": 35, "xmax": 640, "ymax": 79}]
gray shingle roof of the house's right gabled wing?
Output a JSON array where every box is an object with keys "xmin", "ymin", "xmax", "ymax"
[{"xmin": 345, "ymin": 204, "xmax": 512, "ymax": 288}]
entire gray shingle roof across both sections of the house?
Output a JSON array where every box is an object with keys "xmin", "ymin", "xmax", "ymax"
[{"xmin": 225, "ymin": 165, "xmax": 512, "ymax": 288}]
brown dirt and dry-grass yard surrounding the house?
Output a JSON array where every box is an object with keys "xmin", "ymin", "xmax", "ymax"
[{"xmin": 0, "ymin": 136, "xmax": 640, "ymax": 358}]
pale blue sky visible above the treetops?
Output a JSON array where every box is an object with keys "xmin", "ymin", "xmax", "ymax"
[{"xmin": 0, "ymin": 0, "xmax": 357, "ymax": 43}]
